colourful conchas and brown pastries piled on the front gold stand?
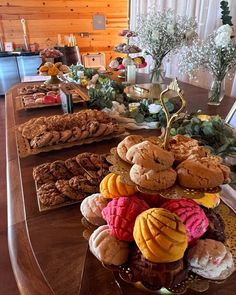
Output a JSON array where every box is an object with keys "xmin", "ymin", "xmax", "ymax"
[{"xmin": 81, "ymin": 135, "xmax": 234, "ymax": 290}]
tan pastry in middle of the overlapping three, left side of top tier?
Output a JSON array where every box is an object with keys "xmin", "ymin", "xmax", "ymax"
[{"xmin": 126, "ymin": 141, "xmax": 174, "ymax": 171}]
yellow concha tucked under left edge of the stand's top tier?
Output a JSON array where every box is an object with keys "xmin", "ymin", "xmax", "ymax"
[{"xmin": 100, "ymin": 173, "xmax": 137, "ymax": 198}]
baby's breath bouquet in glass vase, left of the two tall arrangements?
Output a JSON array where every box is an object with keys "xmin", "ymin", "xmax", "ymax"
[{"xmin": 136, "ymin": 9, "xmax": 197, "ymax": 82}]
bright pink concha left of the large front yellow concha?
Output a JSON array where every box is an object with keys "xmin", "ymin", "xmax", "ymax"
[{"xmin": 102, "ymin": 196, "xmax": 149, "ymax": 241}]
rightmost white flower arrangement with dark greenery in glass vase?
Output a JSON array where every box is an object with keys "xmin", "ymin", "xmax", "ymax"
[{"xmin": 180, "ymin": 1, "xmax": 236, "ymax": 105}]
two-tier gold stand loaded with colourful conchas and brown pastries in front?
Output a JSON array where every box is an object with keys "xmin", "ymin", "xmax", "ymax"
[{"xmin": 80, "ymin": 135, "xmax": 236, "ymax": 294}]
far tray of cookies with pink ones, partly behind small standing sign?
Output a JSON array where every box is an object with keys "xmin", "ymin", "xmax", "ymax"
[{"xmin": 16, "ymin": 83, "xmax": 89, "ymax": 109}]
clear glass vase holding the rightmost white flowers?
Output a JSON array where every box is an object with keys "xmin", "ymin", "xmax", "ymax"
[{"xmin": 208, "ymin": 77, "xmax": 225, "ymax": 105}]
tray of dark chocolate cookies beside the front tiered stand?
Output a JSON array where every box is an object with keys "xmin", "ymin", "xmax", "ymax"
[{"xmin": 33, "ymin": 153, "xmax": 110, "ymax": 211}]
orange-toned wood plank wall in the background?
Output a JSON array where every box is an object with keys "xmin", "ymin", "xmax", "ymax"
[{"xmin": 0, "ymin": 0, "xmax": 129, "ymax": 63}]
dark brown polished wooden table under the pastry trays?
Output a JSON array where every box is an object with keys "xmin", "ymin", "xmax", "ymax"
[{"xmin": 6, "ymin": 79, "xmax": 236, "ymax": 295}]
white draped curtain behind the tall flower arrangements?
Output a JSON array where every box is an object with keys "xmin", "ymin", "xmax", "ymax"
[{"xmin": 130, "ymin": 0, "xmax": 236, "ymax": 96}]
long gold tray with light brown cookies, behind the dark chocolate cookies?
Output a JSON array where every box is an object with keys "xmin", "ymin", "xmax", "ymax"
[{"xmin": 16, "ymin": 109, "xmax": 125, "ymax": 157}]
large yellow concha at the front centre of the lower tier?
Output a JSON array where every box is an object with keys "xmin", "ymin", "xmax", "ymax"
[{"xmin": 133, "ymin": 208, "xmax": 187, "ymax": 263}]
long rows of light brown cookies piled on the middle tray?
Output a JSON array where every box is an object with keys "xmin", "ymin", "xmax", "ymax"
[{"xmin": 18, "ymin": 109, "xmax": 124, "ymax": 149}]
